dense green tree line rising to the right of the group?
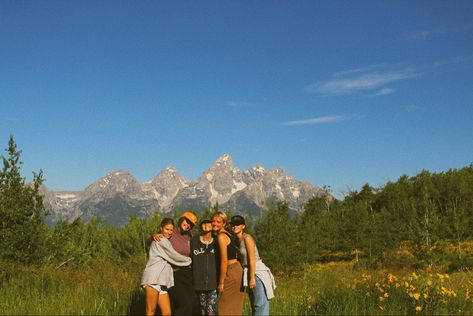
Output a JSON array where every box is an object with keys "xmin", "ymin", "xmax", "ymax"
[{"xmin": 256, "ymin": 164, "xmax": 473, "ymax": 269}]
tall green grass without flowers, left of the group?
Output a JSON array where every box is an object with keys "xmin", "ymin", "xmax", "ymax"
[{"xmin": 0, "ymin": 258, "xmax": 145, "ymax": 315}]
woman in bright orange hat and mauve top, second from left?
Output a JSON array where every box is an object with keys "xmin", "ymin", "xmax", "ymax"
[{"xmin": 153, "ymin": 211, "xmax": 197, "ymax": 315}]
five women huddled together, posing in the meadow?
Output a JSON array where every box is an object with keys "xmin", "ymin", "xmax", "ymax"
[{"xmin": 141, "ymin": 211, "xmax": 276, "ymax": 316}]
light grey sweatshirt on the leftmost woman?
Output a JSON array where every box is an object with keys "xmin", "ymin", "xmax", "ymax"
[{"xmin": 141, "ymin": 238, "xmax": 192, "ymax": 288}]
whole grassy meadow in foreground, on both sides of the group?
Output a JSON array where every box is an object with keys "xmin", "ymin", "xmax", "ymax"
[{"xmin": 0, "ymin": 256, "xmax": 473, "ymax": 315}]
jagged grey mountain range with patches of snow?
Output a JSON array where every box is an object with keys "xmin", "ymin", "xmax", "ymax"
[{"xmin": 41, "ymin": 154, "xmax": 324, "ymax": 226}]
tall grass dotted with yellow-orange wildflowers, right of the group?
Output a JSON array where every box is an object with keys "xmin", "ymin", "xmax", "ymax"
[{"xmin": 271, "ymin": 263, "xmax": 473, "ymax": 315}]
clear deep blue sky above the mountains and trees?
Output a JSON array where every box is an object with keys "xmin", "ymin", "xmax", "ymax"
[{"xmin": 0, "ymin": 0, "xmax": 473, "ymax": 197}]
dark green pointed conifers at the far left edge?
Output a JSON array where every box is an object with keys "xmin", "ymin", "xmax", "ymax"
[{"xmin": 0, "ymin": 136, "xmax": 46, "ymax": 263}]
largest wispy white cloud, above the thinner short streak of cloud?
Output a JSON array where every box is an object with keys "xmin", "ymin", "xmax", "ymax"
[{"xmin": 306, "ymin": 69, "xmax": 417, "ymax": 94}]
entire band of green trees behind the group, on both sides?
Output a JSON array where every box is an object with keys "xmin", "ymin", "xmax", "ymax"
[{"xmin": 0, "ymin": 137, "xmax": 473, "ymax": 271}]
